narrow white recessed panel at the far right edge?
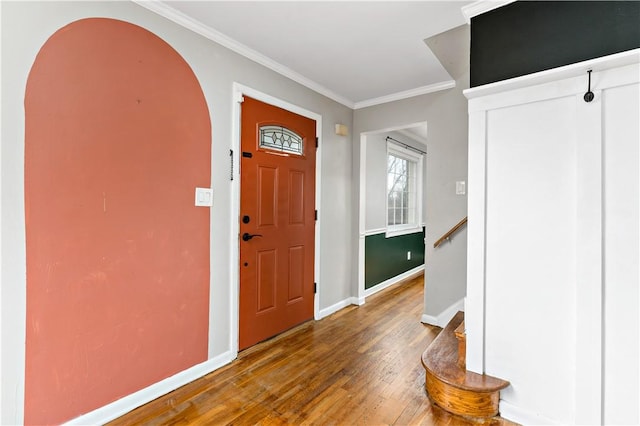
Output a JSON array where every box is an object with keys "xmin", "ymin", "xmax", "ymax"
[{"xmin": 602, "ymin": 83, "xmax": 640, "ymax": 424}]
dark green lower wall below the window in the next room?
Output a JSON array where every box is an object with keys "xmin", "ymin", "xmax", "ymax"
[{"xmin": 364, "ymin": 228, "xmax": 424, "ymax": 289}]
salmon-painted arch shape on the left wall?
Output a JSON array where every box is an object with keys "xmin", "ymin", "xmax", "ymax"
[{"xmin": 24, "ymin": 18, "xmax": 211, "ymax": 424}]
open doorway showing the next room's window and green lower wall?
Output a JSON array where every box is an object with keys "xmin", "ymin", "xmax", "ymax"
[{"xmin": 357, "ymin": 122, "xmax": 427, "ymax": 304}]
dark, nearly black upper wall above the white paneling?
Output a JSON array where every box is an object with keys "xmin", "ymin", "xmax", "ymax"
[{"xmin": 471, "ymin": 1, "xmax": 640, "ymax": 87}]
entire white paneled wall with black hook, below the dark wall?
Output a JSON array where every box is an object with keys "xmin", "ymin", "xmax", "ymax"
[{"xmin": 466, "ymin": 51, "xmax": 640, "ymax": 424}]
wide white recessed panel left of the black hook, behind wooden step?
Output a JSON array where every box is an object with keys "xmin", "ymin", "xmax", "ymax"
[{"xmin": 484, "ymin": 97, "xmax": 577, "ymax": 422}]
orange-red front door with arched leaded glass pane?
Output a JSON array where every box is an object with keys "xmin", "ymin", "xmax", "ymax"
[{"xmin": 239, "ymin": 97, "xmax": 316, "ymax": 349}]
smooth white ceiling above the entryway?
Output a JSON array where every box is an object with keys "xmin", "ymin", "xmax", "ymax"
[{"xmin": 148, "ymin": 0, "xmax": 471, "ymax": 108}]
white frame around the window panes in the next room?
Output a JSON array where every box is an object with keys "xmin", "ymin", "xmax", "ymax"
[{"xmin": 385, "ymin": 142, "xmax": 424, "ymax": 238}]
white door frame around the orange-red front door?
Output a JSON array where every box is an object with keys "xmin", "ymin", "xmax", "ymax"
[{"xmin": 229, "ymin": 82, "xmax": 322, "ymax": 358}]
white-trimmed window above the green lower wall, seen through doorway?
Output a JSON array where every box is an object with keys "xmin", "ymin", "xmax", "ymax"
[{"xmin": 386, "ymin": 143, "xmax": 423, "ymax": 237}]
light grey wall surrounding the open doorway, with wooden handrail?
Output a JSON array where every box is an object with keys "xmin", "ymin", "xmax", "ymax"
[{"xmin": 352, "ymin": 69, "xmax": 469, "ymax": 318}]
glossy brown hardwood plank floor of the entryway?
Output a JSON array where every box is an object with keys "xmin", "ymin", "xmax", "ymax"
[{"xmin": 110, "ymin": 277, "xmax": 512, "ymax": 425}]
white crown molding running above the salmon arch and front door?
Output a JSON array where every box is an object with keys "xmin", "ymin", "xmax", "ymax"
[{"xmin": 132, "ymin": 0, "xmax": 355, "ymax": 109}]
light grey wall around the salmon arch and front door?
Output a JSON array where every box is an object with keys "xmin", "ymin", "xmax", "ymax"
[{"xmin": 0, "ymin": 2, "xmax": 353, "ymax": 424}]
